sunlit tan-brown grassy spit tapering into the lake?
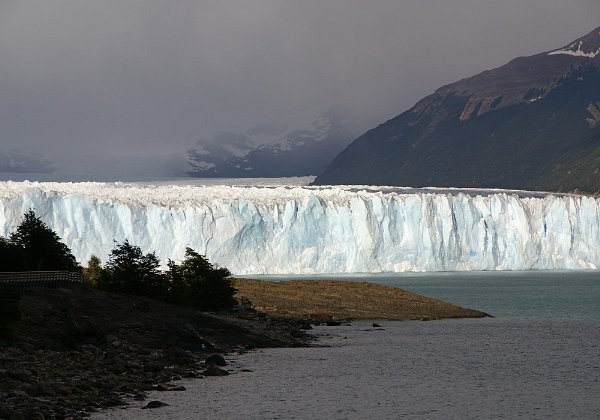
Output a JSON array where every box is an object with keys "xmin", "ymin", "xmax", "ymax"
[{"xmin": 234, "ymin": 279, "xmax": 488, "ymax": 320}]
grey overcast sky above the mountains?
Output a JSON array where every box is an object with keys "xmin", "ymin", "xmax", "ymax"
[{"xmin": 0, "ymin": 0, "xmax": 600, "ymax": 177}]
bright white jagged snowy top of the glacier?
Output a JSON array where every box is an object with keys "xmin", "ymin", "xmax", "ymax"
[{"xmin": 0, "ymin": 178, "xmax": 564, "ymax": 208}]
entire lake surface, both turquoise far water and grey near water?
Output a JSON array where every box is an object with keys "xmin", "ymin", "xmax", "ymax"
[{"xmin": 94, "ymin": 272, "xmax": 600, "ymax": 419}]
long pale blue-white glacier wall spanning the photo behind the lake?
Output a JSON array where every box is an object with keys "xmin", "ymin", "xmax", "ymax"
[{"xmin": 0, "ymin": 181, "xmax": 600, "ymax": 275}]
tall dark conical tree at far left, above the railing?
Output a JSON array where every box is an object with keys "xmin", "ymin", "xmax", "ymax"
[{"xmin": 10, "ymin": 210, "xmax": 81, "ymax": 271}]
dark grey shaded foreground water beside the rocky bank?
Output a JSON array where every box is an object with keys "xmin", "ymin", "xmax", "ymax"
[{"xmin": 92, "ymin": 318, "xmax": 600, "ymax": 420}]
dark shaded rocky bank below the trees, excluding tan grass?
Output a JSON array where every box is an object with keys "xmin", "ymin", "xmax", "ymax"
[{"xmin": 0, "ymin": 287, "xmax": 308, "ymax": 420}]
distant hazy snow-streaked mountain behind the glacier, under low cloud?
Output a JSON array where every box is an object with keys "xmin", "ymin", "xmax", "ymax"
[{"xmin": 188, "ymin": 110, "xmax": 356, "ymax": 178}]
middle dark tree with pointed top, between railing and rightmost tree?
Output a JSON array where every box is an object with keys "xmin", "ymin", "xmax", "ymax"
[{"xmin": 99, "ymin": 240, "xmax": 168, "ymax": 297}]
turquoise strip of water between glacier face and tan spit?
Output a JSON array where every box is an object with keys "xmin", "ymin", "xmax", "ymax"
[{"xmin": 244, "ymin": 271, "xmax": 600, "ymax": 320}]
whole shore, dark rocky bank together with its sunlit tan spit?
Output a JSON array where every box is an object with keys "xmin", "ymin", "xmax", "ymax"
[{"xmin": 0, "ymin": 279, "xmax": 487, "ymax": 420}]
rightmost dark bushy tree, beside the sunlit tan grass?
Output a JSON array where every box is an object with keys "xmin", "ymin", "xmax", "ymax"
[{"xmin": 168, "ymin": 248, "xmax": 236, "ymax": 311}]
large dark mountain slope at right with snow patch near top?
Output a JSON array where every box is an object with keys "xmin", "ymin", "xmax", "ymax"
[{"xmin": 315, "ymin": 28, "xmax": 600, "ymax": 192}]
